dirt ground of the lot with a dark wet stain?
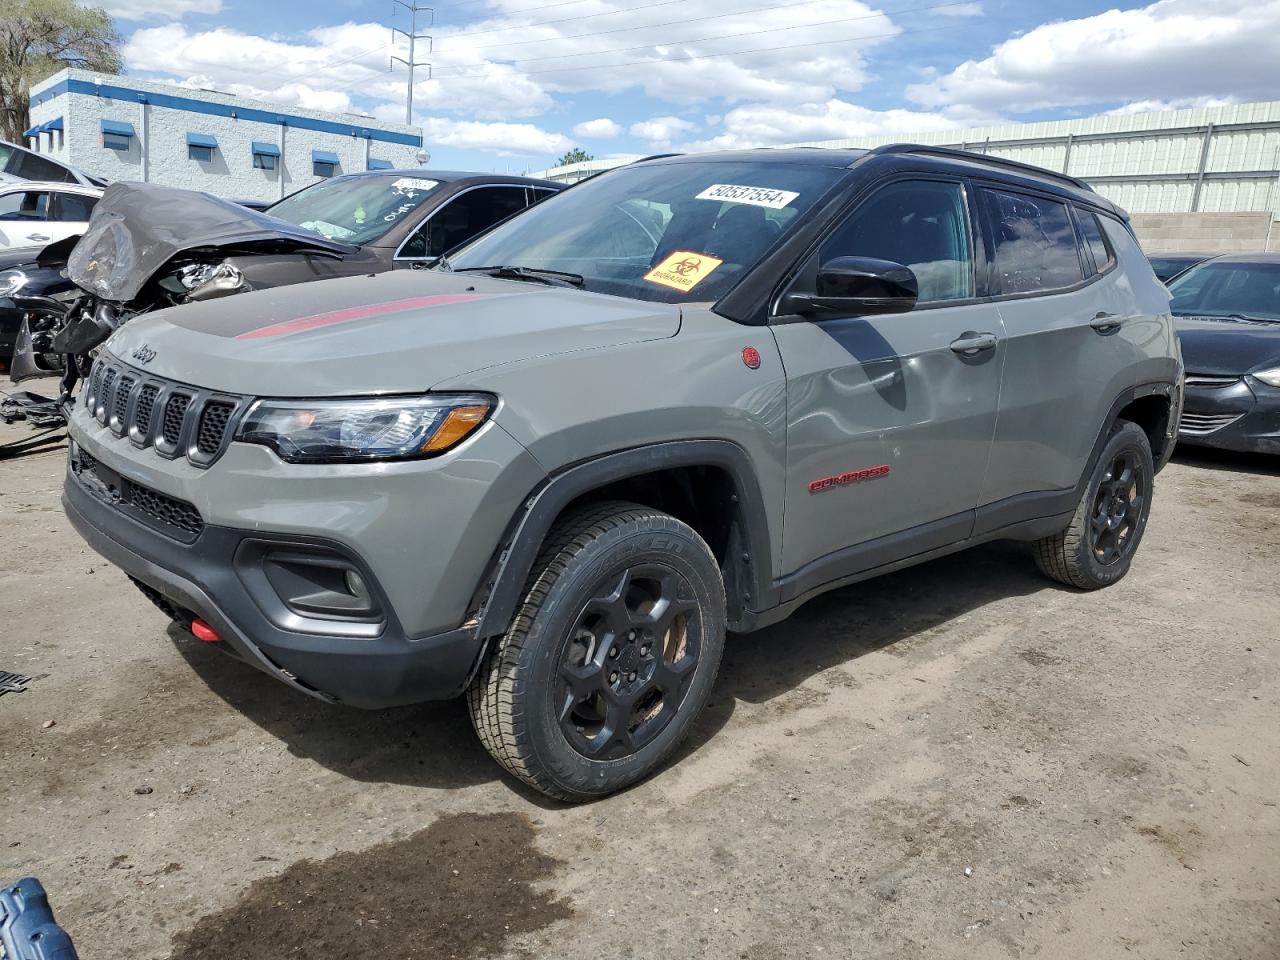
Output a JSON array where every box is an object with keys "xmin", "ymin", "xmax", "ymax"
[{"xmin": 0, "ymin": 391, "xmax": 1280, "ymax": 960}]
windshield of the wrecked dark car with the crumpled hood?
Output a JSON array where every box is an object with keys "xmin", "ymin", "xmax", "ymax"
[{"xmin": 266, "ymin": 174, "xmax": 440, "ymax": 246}]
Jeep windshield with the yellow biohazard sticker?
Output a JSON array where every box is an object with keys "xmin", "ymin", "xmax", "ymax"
[{"xmin": 449, "ymin": 160, "xmax": 845, "ymax": 302}]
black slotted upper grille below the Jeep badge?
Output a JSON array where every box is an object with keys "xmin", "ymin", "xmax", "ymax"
[{"xmin": 82, "ymin": 356, "xmax": 248, "ymax": 467}]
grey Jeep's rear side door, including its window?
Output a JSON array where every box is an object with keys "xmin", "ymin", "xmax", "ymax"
[{"xmin": 979, "ymin": 184, "xmax": 1167, "ymax": 512}]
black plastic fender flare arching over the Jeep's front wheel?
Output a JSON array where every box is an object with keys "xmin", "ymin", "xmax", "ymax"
[{"xmin": 472, "ymin": 440, "xmax": 776, "ymax": 639}]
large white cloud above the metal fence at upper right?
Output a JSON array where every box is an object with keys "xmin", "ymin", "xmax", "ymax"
[{"xmin": 906, "ymin": 0, "xmax": 1280, "ymax": 114}]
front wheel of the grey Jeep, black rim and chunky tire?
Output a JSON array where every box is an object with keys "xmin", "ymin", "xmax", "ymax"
[{"xmin": 467, "ymin": 503, "xmax": 724, "ymax": 801}]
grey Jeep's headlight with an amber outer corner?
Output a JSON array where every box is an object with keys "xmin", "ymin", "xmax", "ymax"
[{"xmin": 237, "ymin": 393, "xmax": 495, "ymax": 463}]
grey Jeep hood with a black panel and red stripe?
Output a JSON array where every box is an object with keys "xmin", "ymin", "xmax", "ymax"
[{"xmin": 106, "ymin": 270, "xmax": 680, "ymax": 397}]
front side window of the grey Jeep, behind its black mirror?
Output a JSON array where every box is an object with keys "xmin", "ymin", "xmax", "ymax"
[{"xmin": 819, "ymin": 180, "xmax": 974, "ymax": 303}]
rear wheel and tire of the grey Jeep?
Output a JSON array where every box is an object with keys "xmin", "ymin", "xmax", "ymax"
[{"xmin": 1036, "ymin": 420, "xmax": 1156, "ymax": 590}]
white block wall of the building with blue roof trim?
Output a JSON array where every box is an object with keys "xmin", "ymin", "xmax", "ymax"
[{"xmin": 28, "ymin": 69, "xmax": 422, "ymax": 201}]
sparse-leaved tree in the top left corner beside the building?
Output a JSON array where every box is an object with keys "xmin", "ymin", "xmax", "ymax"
[{"xmin": 0, "ymin": 0, "xmax": 120, "ymax": 143}]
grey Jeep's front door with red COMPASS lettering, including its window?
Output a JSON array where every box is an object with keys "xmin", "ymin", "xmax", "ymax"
[{"xmin": 773, "ymin": 179, "xmax": 1004, "ymax": 591}]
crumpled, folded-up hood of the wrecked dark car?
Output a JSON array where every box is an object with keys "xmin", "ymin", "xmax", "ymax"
[{"xmin": 67, "ymin": 183, "xmax": 357, "ymax": 302}]
